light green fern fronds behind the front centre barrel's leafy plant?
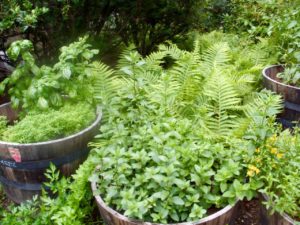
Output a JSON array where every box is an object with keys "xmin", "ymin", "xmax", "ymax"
[{"xmin": 106, "ymin": 33, "xmax": 280, "ymax": 138}]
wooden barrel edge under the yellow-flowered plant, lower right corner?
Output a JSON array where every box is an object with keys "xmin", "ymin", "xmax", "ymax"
[{"xmin": 260, "ymin": 194, "xmax": 300, "ymax": 225}]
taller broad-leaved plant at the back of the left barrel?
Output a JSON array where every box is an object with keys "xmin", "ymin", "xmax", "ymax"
[{"xmin": 0, "ymin": 37, "xmax": 98, "ymax": 110}]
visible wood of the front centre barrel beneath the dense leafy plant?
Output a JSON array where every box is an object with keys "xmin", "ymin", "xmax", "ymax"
[{"xmin": 91, "ymin": 178, "xmax": 238, "ymax": 225}]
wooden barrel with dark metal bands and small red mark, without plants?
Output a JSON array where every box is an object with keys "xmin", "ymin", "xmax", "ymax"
[{"xmin": 0, "ymin": 103, "xmax": 101, "ymax": 203}]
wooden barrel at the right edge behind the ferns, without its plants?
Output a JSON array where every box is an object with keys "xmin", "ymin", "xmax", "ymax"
[{"xmin": 262, "ymin": 65, "xmax": 300, "ymax": 127}]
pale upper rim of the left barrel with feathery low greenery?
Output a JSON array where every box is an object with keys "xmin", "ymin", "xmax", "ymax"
[{"xmin": 0, "ymin": 102, "xmax": 102, "ymax": 147}]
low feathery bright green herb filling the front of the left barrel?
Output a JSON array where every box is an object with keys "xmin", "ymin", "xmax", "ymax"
[{"xmin": 2, "ymin": 103, "xmax": 96, "ymax": 143}]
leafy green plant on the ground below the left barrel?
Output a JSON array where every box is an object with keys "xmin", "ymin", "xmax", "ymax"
[{"xmin": 0, "ymin": 156, "xmax": 102, "ymax": 225}]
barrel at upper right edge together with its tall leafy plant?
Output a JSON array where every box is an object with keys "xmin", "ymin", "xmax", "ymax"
[{"xmin": 263, "ymin": 7, "xmax": 300, "ymax": 127}]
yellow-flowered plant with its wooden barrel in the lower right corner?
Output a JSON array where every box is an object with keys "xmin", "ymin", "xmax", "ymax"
[{"xmin": 248, "ymin": 129, "xmax": 300, "ymax": 225}]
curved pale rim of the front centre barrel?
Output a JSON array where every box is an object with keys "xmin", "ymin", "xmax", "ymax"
[{"xmin": 91, "ymin": 178, "xmax": 239, "ymax": 225}]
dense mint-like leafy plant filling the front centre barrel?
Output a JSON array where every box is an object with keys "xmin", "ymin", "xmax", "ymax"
[{"xmin": 90, "ymin": 114, "xmax": 257, "ymax": 223}]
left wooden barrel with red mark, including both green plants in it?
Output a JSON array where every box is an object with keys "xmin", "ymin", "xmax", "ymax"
[{"xmin": 0, "ymin": 37, "xmax": 101, "ymax": 203}]
